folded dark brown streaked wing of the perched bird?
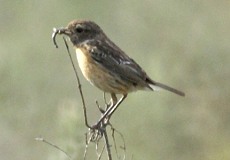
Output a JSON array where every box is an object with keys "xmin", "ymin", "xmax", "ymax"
[{"xmin": 85, "ymin": 41, "xmax": 150, "ymax": 88}]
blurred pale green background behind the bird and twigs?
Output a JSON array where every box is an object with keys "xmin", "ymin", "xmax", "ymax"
[{"xmin": 0, "ymin": 0, "xmax": 230, "ymax": 160}]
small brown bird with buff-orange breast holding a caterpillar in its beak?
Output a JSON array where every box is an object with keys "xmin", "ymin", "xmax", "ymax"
[{"xmin": 53, "ymin": 20, "xmax": 185, "ymax": 124}]
